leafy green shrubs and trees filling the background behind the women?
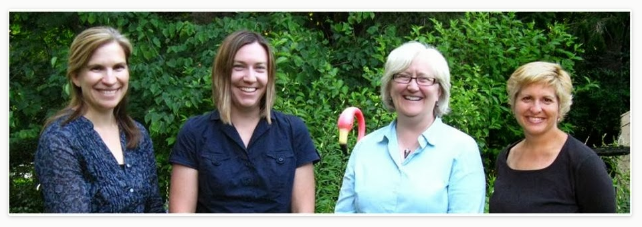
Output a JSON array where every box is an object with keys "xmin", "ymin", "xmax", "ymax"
[{"xmin": 9, "ymin": 12, "xmax": 631, "ymax": 213}]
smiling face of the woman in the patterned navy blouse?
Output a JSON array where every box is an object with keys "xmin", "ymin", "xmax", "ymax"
[{"xmin": 72, "ymin": 42, "xmax": 129, "ymax": 113}]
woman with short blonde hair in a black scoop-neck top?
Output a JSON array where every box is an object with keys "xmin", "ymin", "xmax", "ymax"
[{"xmin": 489, "ymin": 62, "xmax": 615, "ymax": 213}]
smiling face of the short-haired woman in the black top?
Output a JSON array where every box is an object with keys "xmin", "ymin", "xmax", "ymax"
[{"xmin": 513, "ymin": 83, "xmax": 559, "ymax": 135}]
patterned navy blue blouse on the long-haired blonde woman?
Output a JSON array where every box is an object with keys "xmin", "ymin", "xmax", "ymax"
[{"xmin": 35, "ymin": 116, "xmax": 165, "ymax": 213}]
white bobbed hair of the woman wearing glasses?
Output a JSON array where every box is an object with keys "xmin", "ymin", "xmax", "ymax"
[{"xmin": 381, "ymin": 41, "xmax": 450, "ymax": 117}]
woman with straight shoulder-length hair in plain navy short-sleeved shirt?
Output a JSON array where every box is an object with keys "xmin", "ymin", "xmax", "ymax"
[{"xmin": 169, "ymin": 31, "xmax": 319, "ymax": 213}]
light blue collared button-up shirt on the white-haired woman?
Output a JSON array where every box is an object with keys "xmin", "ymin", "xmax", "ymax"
[{"xmin": 334, "ymin": 118, "xmax": 486, "ymax": 213}]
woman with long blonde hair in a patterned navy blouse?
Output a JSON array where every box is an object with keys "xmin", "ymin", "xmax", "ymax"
[{"xmin": 35, "ymin": 27, "xmax": 165, "ymax": 213}]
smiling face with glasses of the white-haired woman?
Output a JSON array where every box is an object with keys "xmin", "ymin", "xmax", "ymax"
[{"xmin": 390, "ymin": 54, "xmax": 441, "ymax": 119}]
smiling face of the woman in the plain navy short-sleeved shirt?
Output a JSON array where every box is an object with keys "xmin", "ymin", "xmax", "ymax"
[{"xmin": 231, "ymin": 42, "xmax": 268, "ymax": 111}]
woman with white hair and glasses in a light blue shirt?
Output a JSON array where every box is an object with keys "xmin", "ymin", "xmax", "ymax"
[{"xmin": 335, "ymin": 41, "xmax": 486, "ymax": 213}]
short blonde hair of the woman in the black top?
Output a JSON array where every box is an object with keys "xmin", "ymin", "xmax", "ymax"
[{"xmin": 506, "ymin": 61, "xmax": 573, "ymax": 121}]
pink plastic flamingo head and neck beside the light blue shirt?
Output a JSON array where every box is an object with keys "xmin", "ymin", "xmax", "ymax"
[{"xmin": 337, "ymin": 107, "xmax": 366, "ymax": 155}]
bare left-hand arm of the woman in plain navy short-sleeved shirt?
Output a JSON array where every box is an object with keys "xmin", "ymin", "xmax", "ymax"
[{"xmin": 169, "ymin": 164, "xmax": 198, "ymax": 213}]
